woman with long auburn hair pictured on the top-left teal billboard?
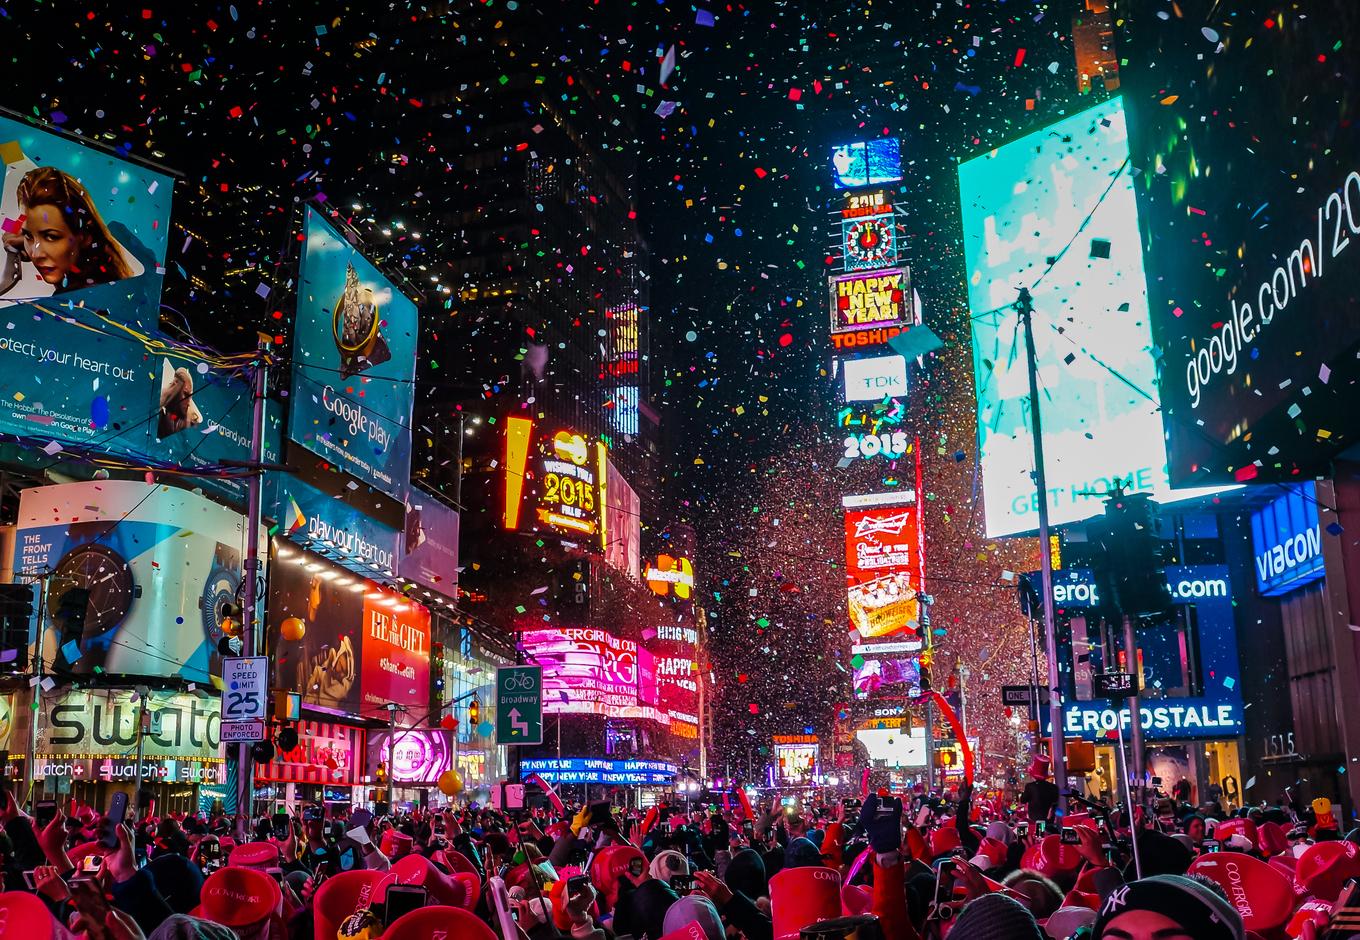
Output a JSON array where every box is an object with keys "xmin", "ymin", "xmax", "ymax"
[{"xmin": 0, "ymin": 161, "xmax": 143, "ymax": 299}]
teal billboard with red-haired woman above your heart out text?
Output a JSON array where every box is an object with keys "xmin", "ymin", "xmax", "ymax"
[{"xmin": 0, "ymin": 117, "xmax": 173, "ymax": 453}]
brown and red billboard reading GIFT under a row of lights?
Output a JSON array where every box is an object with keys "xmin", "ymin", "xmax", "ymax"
[{"xmin": 268, "ymin": 539, "xmax": 430, "ymax": 717}]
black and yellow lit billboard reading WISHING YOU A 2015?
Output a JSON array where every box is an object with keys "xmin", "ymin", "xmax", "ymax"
[{"xmin": 503, "ymin": 418, "xmax": 609, "ymax": 550}]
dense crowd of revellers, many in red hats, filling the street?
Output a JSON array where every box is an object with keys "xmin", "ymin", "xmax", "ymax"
[{"xmin": 0, "ymin": 758, "xmax": 1360, "ymax": 940}]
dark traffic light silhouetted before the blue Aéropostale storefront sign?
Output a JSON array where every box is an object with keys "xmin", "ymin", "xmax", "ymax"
[{"xmin": 1091, "ymin": 490, "xmax": 1171, "ymax": 620}]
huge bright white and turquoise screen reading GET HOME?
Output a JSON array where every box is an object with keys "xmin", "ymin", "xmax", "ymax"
[{"xmin": 959, "ymin": 98, "xmax": 1229, "ymax": 537}]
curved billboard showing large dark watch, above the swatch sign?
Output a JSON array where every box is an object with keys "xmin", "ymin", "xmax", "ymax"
[{"xmin": 15, "ymin": 480, "xmax": 255, "ymax": 683}]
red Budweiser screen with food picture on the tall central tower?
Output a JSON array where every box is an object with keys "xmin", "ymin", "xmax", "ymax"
[{"xmin": 845, "ymin": 503, "xmax": 923, "ymax": 639}]
